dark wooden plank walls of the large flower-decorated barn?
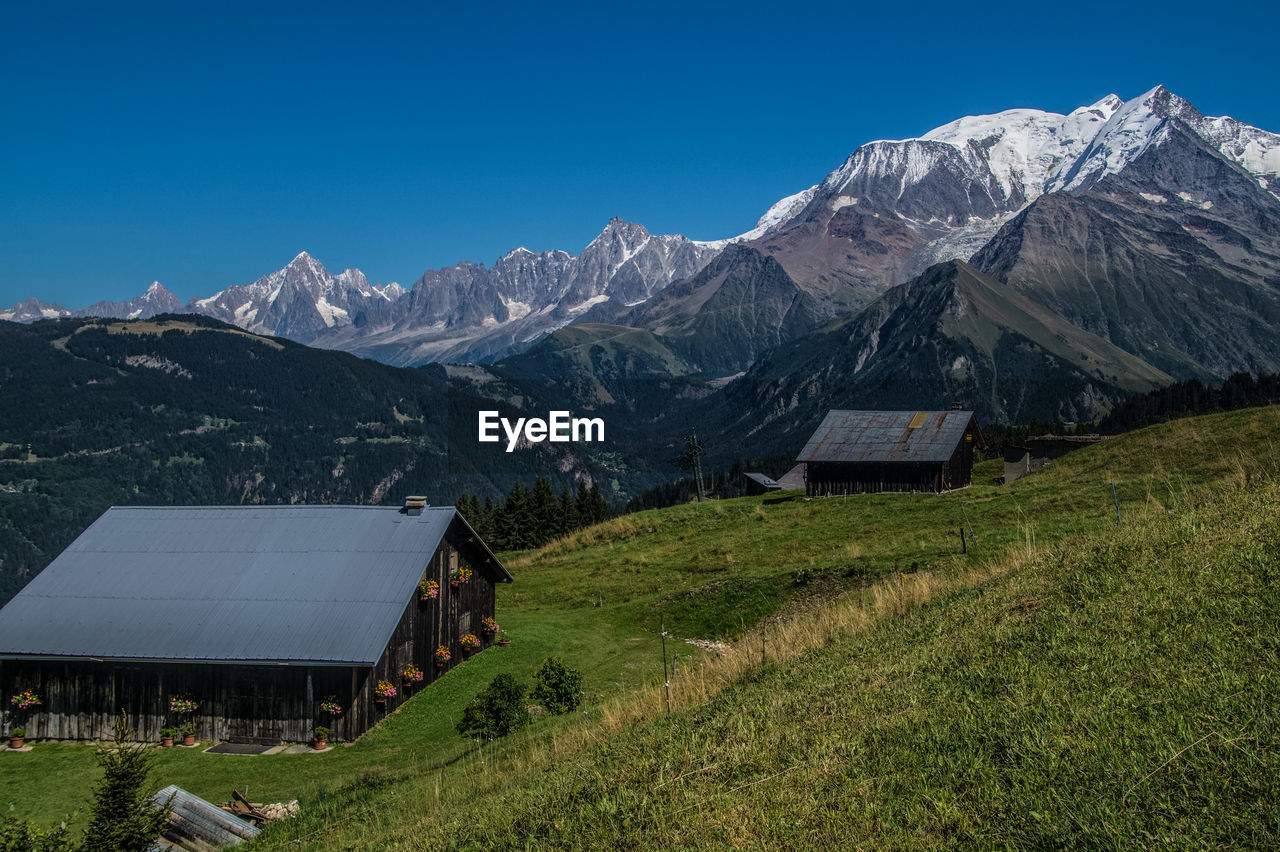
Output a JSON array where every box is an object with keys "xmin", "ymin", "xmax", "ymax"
[{"xmin": 0, "ymin": 530, "xmax": 494, "ymax": 742}]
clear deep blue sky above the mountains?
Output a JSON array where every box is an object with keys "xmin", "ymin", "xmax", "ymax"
[{"xmin": 0, "ymin": 0, "xmax": 1280, "ymax": 307}]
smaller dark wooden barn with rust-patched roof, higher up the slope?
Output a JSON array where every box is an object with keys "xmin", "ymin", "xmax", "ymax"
[{"xmin": 796, "ymin": 411, "xmax": 982, "ymax": 496}]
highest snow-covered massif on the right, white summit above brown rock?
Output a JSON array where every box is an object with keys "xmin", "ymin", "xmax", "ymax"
[{"xmin": 744, "ymin": 86, "xmax": 1280, "ymax": 310}]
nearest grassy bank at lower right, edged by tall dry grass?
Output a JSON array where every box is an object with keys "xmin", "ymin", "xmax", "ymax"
[{"xmin": 252, "ymin": 409, "xmax": 1280, "ymax": 849}]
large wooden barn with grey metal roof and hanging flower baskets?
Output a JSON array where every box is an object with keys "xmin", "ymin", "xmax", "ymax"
[{"xmin": 0, "ymin": 500, "xmax": 511, "ymax": 743}]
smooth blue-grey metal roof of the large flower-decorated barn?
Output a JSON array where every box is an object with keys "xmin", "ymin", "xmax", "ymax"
[{"xmin": 0, "ymin": 505, "xmax": 511, "ymax": 665}]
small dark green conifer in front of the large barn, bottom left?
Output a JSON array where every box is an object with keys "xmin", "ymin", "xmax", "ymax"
[{"xmin": 83, "ymin": 710, "xmax": 172, "ymax": 852}]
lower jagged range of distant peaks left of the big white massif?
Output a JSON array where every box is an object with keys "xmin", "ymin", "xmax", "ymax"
[{"xmin": 0, "ymin": 217, "xmax": 723, "ymax": 365}]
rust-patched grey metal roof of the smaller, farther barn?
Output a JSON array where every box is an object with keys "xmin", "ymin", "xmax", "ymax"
[{"xmin": 796, "ymin": 411, "xmax": 973, "ymax": 462}]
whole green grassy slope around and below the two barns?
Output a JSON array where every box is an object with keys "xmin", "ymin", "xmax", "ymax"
[{"xmin": 0, "ymin": 408, "xmax": 1280, "ymax": 848}]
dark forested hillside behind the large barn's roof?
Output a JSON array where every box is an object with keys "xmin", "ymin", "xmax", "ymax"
[{"xmin": 0, "ymin": 317, "xmax": 624, "ymax": 601}]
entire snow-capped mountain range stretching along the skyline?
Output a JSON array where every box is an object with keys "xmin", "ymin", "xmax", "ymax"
[{"xmin": 10, "ymin": 86, "xmax": 1280, "ymax": 373}]
